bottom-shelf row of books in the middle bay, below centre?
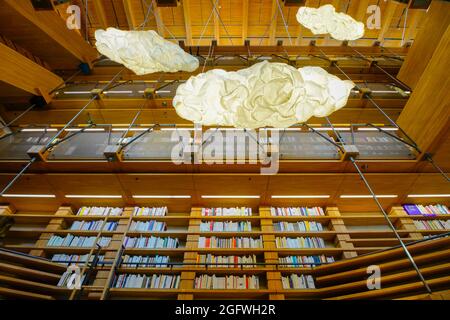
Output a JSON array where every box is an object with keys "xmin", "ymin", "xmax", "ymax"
[{"xmin": 194, "ymin": 274, "xmax": 259, "ymax": 289}]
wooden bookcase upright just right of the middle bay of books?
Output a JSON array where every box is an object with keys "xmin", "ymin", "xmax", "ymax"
[{"xmin": 259, "ymin": 207, "xmax": 284, "ymax": 300}]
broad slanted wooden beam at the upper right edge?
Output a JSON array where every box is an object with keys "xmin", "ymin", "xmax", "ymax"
[{"xmin": 397, "ymin": 1, "xmax": 450, "ymax": 153}]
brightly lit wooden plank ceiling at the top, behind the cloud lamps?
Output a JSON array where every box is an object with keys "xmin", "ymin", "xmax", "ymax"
[{"xmin": 76, "ymin": 0, "xmax": 426, "ymax": 47}]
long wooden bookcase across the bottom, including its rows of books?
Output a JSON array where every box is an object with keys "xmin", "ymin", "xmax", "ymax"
[{"xmin": 0, "ymin": 206, "xmax": 450, "ymax": 300}]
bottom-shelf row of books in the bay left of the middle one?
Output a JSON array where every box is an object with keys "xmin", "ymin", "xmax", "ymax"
[{"xmin": 114, "ymin": 274, "xmax": 181, "ymax": 289}]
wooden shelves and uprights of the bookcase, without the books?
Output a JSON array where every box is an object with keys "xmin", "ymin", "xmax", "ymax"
[{"xmin": 0, "ymin": 206, "xmax": 450, "ymax": 300}]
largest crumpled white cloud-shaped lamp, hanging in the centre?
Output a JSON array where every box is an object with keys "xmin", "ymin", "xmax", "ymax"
[{"xmin": 173, "ymin": 61, "xmax": 355, "ymax": 128}]
